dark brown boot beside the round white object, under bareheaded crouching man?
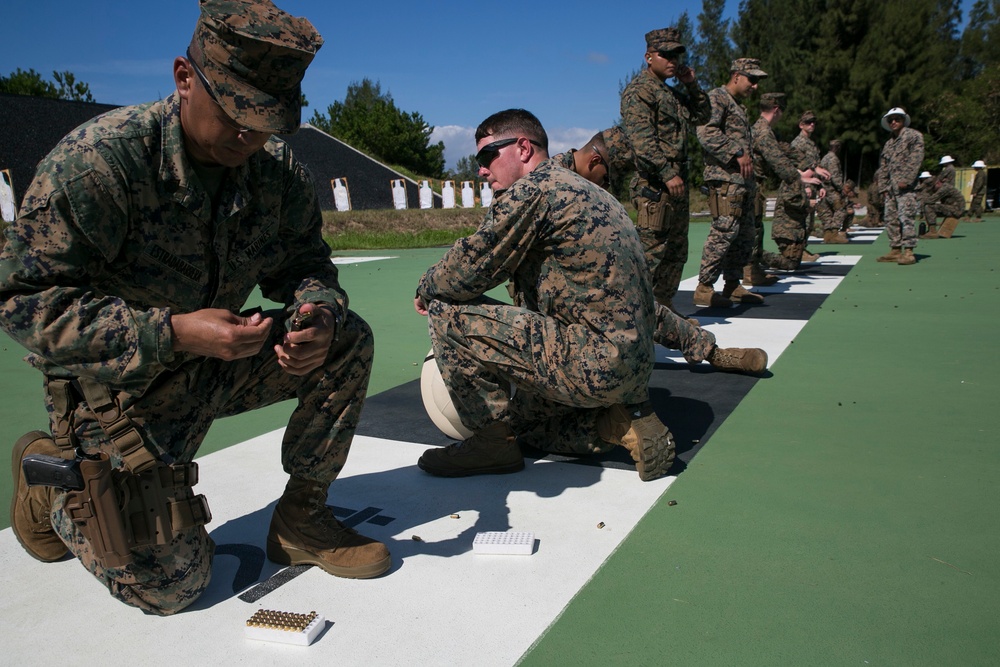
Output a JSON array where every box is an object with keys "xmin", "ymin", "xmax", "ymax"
[{"xmin": 417, "ymin": 421, "xmax": 524, "ymax": 477}]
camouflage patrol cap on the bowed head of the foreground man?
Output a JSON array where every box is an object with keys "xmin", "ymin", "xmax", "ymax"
[{"xmin": 187, "ymin": 0, "xmax": 323, "ymax": 134}]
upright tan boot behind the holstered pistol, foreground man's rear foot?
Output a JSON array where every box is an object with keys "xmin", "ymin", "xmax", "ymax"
[{"xmin": 10, "ymin": 431, "xmax": 67, "ymax": 563}]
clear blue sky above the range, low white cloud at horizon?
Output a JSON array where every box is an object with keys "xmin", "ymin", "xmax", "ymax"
[{"xmin": 0, "ymin": 0, "xmax": 971, "ymax": 166}]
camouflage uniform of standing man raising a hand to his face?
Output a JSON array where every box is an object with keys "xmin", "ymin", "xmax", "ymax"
[{"xmin": 621, "ymin": 31, "xmax": 711, "ymax": 304}]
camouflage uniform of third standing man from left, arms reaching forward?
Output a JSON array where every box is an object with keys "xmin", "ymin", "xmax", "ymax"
[{"xmin": 752, "ymin": 116, "xmax": 809, "ymax": 271}]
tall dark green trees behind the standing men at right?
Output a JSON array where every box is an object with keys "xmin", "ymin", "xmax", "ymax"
[{"xmin": 677, "ymin": 0, "xmax": 1000, "ymax": 187}]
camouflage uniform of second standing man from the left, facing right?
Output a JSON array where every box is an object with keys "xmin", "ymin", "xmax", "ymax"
[{"xmin": 698, "ymin": 86, "xmax": 757, "ymax": 285}]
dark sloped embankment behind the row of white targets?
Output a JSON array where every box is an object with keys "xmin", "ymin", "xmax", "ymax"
[{"xmin": 0, "ymin": 93, "xmax": 441, "ymax": 210}]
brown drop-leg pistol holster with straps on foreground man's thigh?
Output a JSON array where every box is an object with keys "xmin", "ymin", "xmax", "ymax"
[{"xmin": 24, "ymin": 378, "xmax": 212, "ymax": 567}]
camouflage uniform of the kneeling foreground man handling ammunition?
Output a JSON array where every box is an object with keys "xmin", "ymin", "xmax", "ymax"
[{"xmin": 0, "ymin": 43, "xmax": 373, "ymax": 614}]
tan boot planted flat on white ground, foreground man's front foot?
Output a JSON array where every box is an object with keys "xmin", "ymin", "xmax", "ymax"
[{"xmin": 267, "ymin": 477, "xmax": 392, "ymax": 579}]
